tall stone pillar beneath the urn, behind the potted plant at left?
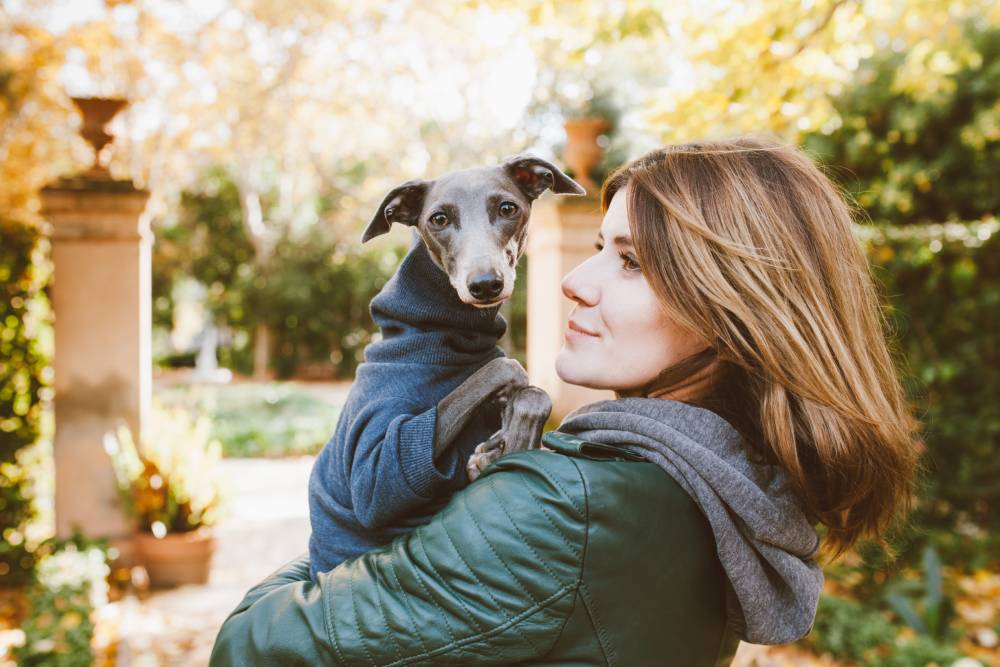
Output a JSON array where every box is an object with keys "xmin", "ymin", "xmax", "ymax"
[{"xmin": 42, "ymin": 175, "xmax": 152, "ymax": 555}]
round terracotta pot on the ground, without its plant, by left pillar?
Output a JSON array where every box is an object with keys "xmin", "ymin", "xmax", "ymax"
[{"xmin": 135, "ymin": 527, "xmax": 215, "ymax": 588}]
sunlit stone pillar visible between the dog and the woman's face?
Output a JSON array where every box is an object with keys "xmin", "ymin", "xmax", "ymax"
[{"xmin": 527, "ymin": 194, "xmax": 614, "ymax": 421}]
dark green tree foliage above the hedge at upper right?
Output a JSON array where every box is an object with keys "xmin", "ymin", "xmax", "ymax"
[{"xmin": 804, "ymin": 27, "xmax": 1000, "ymax": 224}]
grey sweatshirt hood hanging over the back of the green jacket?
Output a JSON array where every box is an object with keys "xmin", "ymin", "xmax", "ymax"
[{"xmin": 557, "ymin": 398, "xmax": 823, "ymax": 644}]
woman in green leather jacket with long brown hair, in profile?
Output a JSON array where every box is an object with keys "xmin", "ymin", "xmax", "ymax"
[{"xmin": 212, "ymin": 138, "xmax": 919, "ymax": 665}]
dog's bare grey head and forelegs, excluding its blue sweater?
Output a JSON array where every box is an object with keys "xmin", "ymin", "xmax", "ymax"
[{"xmin": 361, "ymin": 155, "xmax": 586, "ymax": 480}]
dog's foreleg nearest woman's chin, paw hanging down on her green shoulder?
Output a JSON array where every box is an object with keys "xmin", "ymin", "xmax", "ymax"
[{"xmin": 465, "ymin": 386, "xmax": 552, "ymax": 481}]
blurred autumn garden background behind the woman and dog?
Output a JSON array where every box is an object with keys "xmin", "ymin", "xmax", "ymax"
[{"xmin": 0, "ymin": 0, "xmax": 1000, "ymax": 667}]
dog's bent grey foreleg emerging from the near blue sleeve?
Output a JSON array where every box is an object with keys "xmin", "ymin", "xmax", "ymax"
[{"xmin": 434, "ymin": 357, "xmax": 528, "ymax": 461}]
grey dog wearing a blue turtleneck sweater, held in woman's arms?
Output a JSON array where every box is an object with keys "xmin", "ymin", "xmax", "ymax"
[{"xmin": 309, "ymin": 155, "xmax": 585, "ymax": 580}]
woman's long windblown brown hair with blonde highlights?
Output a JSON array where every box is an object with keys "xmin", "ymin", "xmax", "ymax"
[{"xmin": 601, "ymin": 137, "xmax": 922, "ymax": 559}]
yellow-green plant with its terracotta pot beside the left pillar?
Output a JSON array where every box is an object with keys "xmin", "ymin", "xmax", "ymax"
[{"xmin": 105, "ymin": 409, "xmax": 221, "ymax": 587}]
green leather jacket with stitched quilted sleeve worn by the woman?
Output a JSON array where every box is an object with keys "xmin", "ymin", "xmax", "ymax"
[{"xmin": 211, "ymin": 433, "xmax": 739, "ymax": 667}]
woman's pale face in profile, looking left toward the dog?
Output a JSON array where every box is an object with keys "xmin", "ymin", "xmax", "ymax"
[{"xmin": 556, "ymin": 186, "xmax": 705, "ymax": 392}]
